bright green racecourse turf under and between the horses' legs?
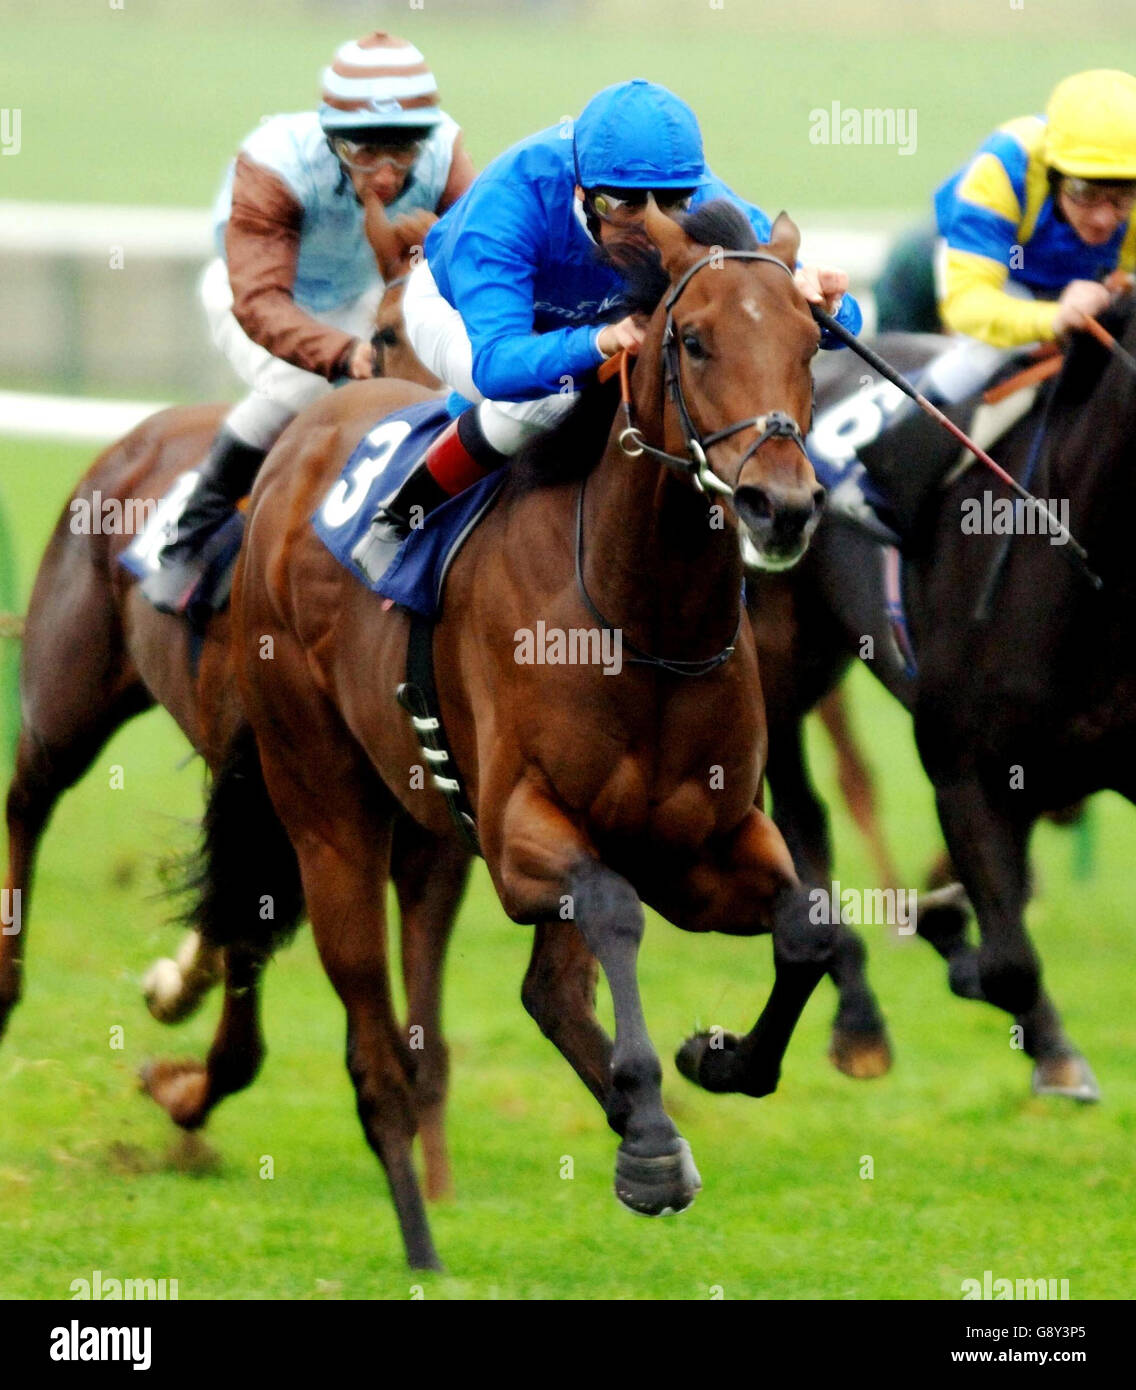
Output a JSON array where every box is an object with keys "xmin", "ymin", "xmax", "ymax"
[{"xmin": 0, "ymin": 442, "xmax": 1136, "ymax": 1298}]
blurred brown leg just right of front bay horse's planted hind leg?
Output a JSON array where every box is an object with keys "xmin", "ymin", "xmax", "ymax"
[{"xmin": 391, "ymin": 821, "xmax": 470, "ymax": 1201}]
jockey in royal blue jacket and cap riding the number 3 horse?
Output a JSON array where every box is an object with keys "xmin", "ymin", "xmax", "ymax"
[{"xmin": 371, "ymin": 79, "xmax": 861, "ymax": 545}]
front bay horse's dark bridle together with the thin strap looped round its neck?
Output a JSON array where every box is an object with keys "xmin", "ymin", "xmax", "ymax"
[{"xmin": 576, "ymin": 252, "xmax": 805, "ymax": 676}]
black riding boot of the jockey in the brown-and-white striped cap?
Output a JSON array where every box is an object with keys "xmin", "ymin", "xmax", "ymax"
[{"xmin": 142, "ymin": 427, "xmax": 266, "ymax": 613}]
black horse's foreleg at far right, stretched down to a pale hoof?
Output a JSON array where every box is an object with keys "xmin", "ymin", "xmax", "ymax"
[{"xmin": 936, "ymin": 778, "xmax": 1100, "ymax": 1101}]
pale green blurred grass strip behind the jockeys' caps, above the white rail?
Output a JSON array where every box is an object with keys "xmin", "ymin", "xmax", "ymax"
[{"xmin": 0, "ymin": 0, "xmax": 1136, "ymax": 214}]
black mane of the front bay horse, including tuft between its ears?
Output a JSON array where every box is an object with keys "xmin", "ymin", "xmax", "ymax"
[{"xmin": 510, "ymin": 197, "xmax": 761, "ymax": 492}]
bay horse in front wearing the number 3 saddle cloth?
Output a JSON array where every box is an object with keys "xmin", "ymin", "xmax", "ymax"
[{"xmin": 208, "ymin": 203, "xmax": 836, "ymax": 1268}]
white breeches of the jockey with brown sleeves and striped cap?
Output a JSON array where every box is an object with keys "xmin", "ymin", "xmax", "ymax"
[{"xmin": 197, "ymin": 257, "xmax": 382, "ymax": 449}]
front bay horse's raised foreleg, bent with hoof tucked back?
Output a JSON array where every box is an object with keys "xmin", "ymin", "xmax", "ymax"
[{"xmin": 674, "ymin": 809, "xmax": 837, "ymax": 1095}]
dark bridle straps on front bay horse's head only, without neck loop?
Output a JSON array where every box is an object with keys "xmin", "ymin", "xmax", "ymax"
[{"xmin": 619, "ymin": 252, "xmax": 805, "ymax": 496}]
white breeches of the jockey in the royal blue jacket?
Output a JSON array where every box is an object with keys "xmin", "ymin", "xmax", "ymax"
[{"xmin": 402, "ymin": 261, "xmax": 578, "ymax": 455}]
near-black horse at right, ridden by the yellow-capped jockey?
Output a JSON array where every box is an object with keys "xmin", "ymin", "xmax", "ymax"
[{"xmin": 754, "ymin": 295, "xmax": 1136, "ymax": 1099}]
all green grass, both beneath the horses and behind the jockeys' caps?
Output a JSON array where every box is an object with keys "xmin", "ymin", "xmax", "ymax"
[{"xmin": 0, "ymin": 0, "xmax": 1136, "ymax": 1298}]
